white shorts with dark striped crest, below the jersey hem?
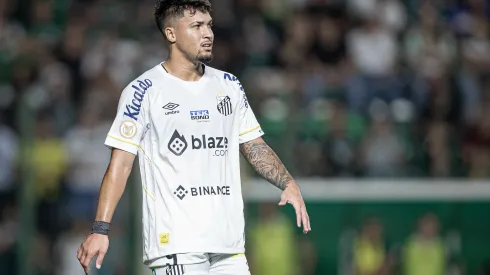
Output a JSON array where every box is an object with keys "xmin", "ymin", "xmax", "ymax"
[{"xmin": 151, "ymin": 253, "xmax": 250, "ymax": 275}]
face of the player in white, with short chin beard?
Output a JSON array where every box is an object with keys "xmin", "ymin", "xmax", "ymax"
[{"xmin": 175, "ymin": 10, "xmax": 214, "ymax": 63}]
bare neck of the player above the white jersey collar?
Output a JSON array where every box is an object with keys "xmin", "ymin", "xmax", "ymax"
[{"xmin": 162, "ymin": 57, "xmax": 204, "ymax": 81}]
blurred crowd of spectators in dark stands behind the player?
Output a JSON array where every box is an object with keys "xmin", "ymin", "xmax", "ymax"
[{"xmin": 0, "ymin": 0, "xmax": 490, "ymax": 274}]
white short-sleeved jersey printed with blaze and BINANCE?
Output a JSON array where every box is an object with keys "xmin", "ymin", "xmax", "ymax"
[{"xmin": 105, "ymin": 64, "xmax": 263, "ymax": 267}]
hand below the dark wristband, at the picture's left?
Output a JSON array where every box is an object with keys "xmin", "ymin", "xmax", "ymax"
[{"xmin": 77, "ymin": 234, "xmax": 109, "ymax": 274}]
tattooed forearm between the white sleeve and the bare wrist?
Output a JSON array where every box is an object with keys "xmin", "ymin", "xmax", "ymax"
[{"xmin": 240, "ymin": 139, "xmax": 293, "ymax": 190}]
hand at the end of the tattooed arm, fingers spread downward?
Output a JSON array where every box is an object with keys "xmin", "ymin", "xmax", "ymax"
[{"xmin": 279, "ymin": 182, "xmax": 311, "ymax": 234}]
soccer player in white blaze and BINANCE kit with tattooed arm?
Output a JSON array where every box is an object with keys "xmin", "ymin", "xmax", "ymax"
[{"xmin": 77, "ymin": 0, "xmax": 311, "ymax": 275}]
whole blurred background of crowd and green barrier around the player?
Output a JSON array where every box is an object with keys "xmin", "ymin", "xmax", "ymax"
[{"xmin": 0, "ymin": 0, "xmax": 490, "ymax": 275}]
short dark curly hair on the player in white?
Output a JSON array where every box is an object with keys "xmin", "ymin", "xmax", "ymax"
[{"xmin": 153, "ymin": 0, "xmax": 211, "ymax": 36}]
